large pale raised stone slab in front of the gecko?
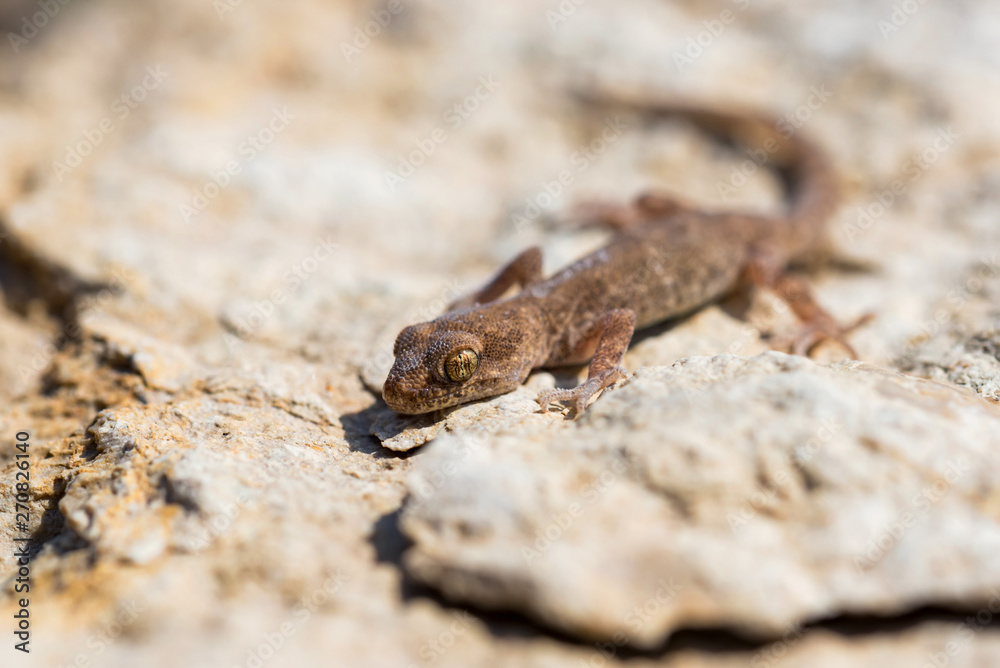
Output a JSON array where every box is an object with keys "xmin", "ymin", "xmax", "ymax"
[{"xmin": 403, "ymin": 353, "xmax": 1000, "ymax": 647}]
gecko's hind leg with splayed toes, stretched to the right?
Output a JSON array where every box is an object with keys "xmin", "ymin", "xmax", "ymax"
[{"xmin": 745, "ymin": 254, "xmax": 875, "ymax": 359}]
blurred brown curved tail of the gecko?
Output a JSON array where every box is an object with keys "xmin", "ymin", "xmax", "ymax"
[{"xmin": 574, "ymin": 90, "xmax": 840, "ymax": 252}]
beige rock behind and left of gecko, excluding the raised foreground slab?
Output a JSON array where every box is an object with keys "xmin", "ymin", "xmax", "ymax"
[{"xmin": 0, "ymin": 0, "xmax": 1000, "ymax": 666}]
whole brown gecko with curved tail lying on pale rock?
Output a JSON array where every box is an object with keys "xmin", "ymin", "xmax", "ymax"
[{"xmin": 382, "ymin": 91, "xmax": 872, "ymax": 416}]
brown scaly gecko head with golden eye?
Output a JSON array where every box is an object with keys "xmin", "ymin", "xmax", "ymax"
[{"xmin": 382, "ymin": 314, "xmax": 522, "ymax": 415}]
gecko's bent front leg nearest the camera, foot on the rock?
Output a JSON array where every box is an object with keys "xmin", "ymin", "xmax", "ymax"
[{"xmin": 538, "ymin": 309, "xmax": 635, "ymax": 416}]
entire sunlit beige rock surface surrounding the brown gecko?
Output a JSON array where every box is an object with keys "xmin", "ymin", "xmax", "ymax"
[{"xmin": 0, "ymin": 0, "xmax": 1000, "ymax": 668}]
